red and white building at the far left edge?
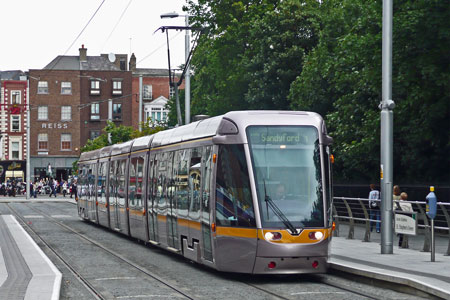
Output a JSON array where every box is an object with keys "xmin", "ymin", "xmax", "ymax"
[{"xmin": 0, "ymin": 71, "xmax": 28, "ymax": 182}]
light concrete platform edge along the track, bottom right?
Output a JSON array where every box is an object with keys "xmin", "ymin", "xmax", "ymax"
[{"xmin": 328, "ymin": 260, "xmax": 450, "ymax": 299}]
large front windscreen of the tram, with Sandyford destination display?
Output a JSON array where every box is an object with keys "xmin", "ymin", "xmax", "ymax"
[{"xmin": 247, "ymin": 126, "xmax": 324, "ymax": 232}]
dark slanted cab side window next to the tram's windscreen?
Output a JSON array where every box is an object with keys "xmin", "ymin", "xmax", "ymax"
[{"xmin": 216, "ymin": 145, "xmax": 256, "ymax": 227}]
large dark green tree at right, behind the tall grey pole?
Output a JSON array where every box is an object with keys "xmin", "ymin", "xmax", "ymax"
[{"xmin": 289, "ymin": 0, "xmax": 450, "ymax": 182}]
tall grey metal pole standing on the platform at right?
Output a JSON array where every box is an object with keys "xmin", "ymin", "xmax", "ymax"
[{"xmin": 380, "ymin": 0, "xmax": 395, "ymax": 254}]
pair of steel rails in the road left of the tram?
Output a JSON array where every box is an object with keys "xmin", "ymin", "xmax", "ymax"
[{"xmin": 6, "ymin": 203, "xmax": 195, "ymax": 299}]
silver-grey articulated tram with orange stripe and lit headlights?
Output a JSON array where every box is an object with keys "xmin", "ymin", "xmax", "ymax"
[{"xmin": 77, "ymin": 111, "xmax": 332, "ymax": 274}]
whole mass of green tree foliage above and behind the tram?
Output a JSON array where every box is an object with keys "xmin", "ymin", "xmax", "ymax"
[{"xmin": 184, "ymin": 0, "xmax": 450, "ymax": 184}]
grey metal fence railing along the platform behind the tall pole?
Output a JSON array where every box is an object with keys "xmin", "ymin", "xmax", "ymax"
[{"xmin": 333, "ymin": 197, "xmax": 450, "ymax": 255}]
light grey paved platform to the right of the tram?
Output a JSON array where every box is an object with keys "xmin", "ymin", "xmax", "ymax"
[{"xmin": 330, "ymin": 237, "xmax": 450, "ymax": 299}]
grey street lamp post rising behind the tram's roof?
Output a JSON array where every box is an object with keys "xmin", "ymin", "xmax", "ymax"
[{"xmin": 161, "ymin": 12, "xmax": 191, "ymax": 124}]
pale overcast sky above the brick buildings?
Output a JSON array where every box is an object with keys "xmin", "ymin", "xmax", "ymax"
[{"xmin": 0, "ymin": 0, "xmax": 191, "ymax": 71}]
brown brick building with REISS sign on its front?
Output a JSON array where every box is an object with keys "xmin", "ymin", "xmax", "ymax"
[{"xmin": 29, "ymin": 45, "xmax": 133, "ymax": 180}]
